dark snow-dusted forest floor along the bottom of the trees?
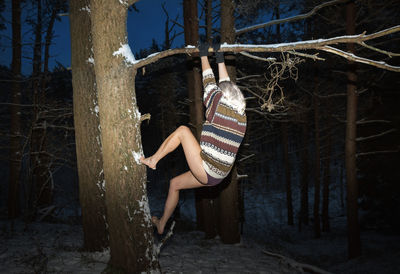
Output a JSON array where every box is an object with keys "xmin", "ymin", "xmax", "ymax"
[{"xmin": 0, "ymin": 202, "xmax": 400, "ymax": 274}]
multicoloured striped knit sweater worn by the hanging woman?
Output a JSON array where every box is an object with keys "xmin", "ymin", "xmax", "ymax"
[{"xmin": 200, "ymin": 69, "xmax": 246, "ymax": 185}]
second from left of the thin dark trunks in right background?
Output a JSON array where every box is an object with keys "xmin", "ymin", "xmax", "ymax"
[{"xmin": 299, "ymin": 113, "xmax": 309, "ymax": 230}]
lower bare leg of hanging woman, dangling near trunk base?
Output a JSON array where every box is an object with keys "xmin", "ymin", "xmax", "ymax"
[{"xmin": 152, "ymin": 171, "xmax": 204, "ymax": 234}]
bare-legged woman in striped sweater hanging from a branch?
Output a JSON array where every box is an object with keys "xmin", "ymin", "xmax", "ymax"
[{"xmin": 140, "ymin": 43, "xmax": 246, "ymax": 234}]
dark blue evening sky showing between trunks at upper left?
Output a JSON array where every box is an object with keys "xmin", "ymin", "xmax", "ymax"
[{"xmin": 0, "ymin": 0, "xmax": 183, "ymax": 75}]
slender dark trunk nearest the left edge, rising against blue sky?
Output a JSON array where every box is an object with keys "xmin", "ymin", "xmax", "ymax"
[{"xmin": 7, "ymin": 0, "xmax": 22, "ymax": 219}]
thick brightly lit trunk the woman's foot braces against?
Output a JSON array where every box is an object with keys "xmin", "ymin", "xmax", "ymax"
[{"xmin": 90, "ymin": 0, "xmax": 159, "ymax": 273}]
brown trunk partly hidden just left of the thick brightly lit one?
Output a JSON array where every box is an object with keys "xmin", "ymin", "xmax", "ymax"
[{"xmin": 69, "ymin": 0, "xmax": 108, "ymax": 251}]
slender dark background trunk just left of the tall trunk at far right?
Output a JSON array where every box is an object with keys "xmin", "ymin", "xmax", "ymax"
[{"xmin": 322, "ymin": 118, "xmax": 332, "ymax": 232}]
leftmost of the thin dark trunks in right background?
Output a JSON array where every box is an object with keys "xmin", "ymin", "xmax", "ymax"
[{"xmin": 282, "ymin": 122, "xmax": 293, "ymax": 225}]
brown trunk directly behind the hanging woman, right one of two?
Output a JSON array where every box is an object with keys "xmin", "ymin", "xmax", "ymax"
[{"xmin": 218, "ymin": 0, "xmax": 240, "ymax": 244}]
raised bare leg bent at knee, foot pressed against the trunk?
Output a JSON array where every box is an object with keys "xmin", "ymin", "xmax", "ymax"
[{"xmin": 140, "ymin": 126, "xmax": 207, "ymax": 184}]
